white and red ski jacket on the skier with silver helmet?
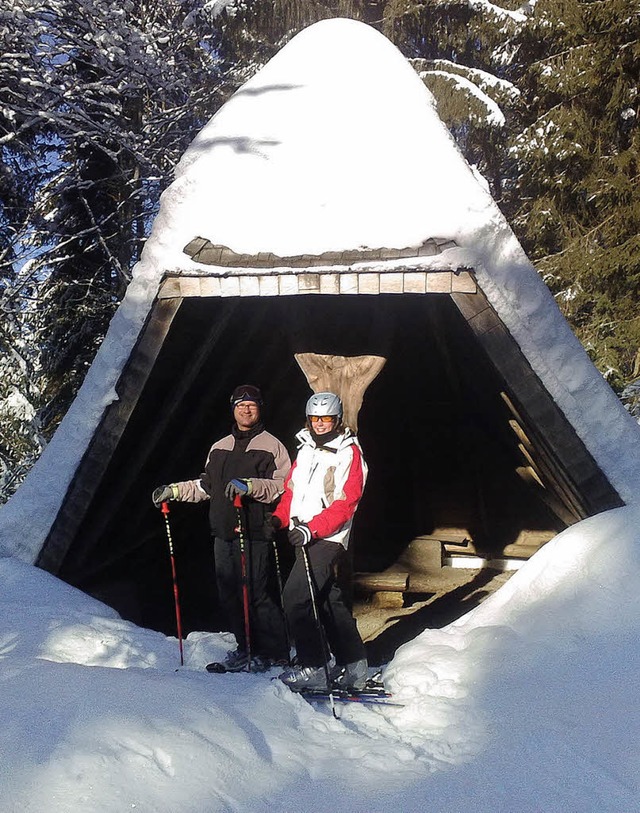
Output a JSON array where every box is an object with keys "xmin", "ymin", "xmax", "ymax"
[{"xmin": 274, "ymin": 429, "xmax": 367, "ymax": 548}]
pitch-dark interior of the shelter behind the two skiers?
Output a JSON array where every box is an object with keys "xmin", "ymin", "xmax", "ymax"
[{"xmin": 58, "ymin": 294, "xmax": 562, "ymax": 634}]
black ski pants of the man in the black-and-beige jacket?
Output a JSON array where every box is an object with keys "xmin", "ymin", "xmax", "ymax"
[{"xmin": 213, "ymin": 537, "xmax": 289, "ymax": 661}]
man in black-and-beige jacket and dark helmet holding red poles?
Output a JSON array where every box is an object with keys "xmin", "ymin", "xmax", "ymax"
[{"xmin": 152, "ymin": 384, "xmax": 291, "ymax": 671}]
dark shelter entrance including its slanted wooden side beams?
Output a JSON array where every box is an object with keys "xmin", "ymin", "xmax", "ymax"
[{"xmin": 38, "ymin": 275, "xmax": 620, "ymax": 632}]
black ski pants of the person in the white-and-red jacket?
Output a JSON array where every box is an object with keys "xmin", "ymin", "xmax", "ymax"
[{"xmin": 283, "ymin": 539, "xmax": 366, "ymax": 666}]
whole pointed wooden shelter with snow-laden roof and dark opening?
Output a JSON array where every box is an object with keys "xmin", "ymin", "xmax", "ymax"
[{"xmin": 0, "ymin": 15, "xmax": 640, "ymax": 629}]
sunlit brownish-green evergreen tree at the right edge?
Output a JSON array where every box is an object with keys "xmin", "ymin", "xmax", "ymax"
[{"xmin": 506, "ymin": 0, "xmax": 640, "ymax": 389}]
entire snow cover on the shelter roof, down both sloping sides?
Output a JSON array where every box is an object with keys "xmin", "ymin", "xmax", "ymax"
[{"xmin": 0, "ymin": 19, "xmax": 640, "ymax": 560}]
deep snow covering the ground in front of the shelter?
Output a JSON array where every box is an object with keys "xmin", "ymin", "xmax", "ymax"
[{"xmin": 0, "ymin": 507, "xmax": 640, "ymax": 813}]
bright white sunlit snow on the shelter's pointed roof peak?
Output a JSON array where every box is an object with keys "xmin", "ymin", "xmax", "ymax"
[{"xmin": 140, "ymin": 19, "xmax": 492, "ymax": 272}]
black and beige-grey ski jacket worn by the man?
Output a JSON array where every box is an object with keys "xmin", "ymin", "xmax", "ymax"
[{"xmin": 174, "ymin": 423, "xmax": 291, "ymax": 539}]
